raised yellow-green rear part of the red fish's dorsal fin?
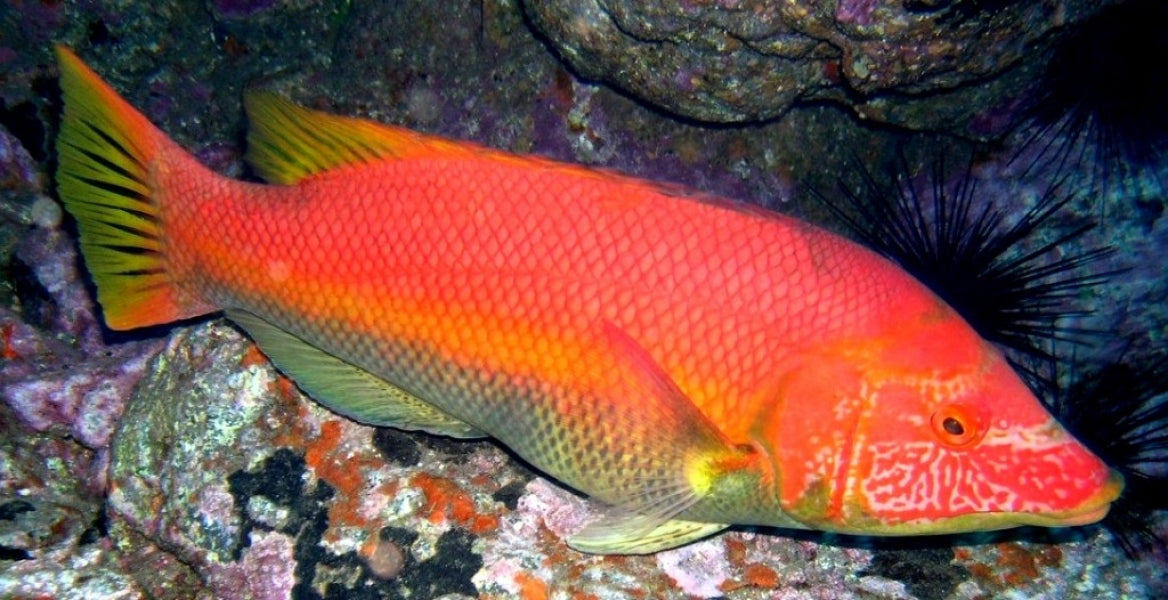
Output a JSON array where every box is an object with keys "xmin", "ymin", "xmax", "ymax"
[{"xmin": 244, "ymin": 91, "xmax": 481, "ymax": 184}]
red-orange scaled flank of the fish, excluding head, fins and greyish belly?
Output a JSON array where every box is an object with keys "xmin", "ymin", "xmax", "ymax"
[{"xmin": 175, "ymin": 153, "xmax": 901, "ymax": 442}]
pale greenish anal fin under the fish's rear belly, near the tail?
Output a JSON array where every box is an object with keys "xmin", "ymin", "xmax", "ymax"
[{"xmin": 227, "ymin": 311, "xmax": 486, "ymax": 438}]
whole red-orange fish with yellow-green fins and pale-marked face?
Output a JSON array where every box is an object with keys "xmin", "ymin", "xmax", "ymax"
[{"xmin": 56, "ymin": 47, "xmax": 1124, "ymax": 553}]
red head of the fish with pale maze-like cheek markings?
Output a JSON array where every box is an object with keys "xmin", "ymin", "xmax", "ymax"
[{"xmin": 770, "ymin": 307, "xmax": 1124, "ymax": 536}]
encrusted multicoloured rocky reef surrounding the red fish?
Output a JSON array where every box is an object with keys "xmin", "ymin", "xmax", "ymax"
[{"xmin": 0, "ymin": 0, "xmax": 1168, "ymax": 600}]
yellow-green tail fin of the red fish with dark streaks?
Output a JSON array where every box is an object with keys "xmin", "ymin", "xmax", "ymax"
[{"xmin": 56, "ymin": 46, "xmax": 213, "ymax": 329}]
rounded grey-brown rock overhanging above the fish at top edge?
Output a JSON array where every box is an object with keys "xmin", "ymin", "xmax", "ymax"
[{"xmin": 524, "ymin": 0, "xmax": 1104, "ymax": 128}]
